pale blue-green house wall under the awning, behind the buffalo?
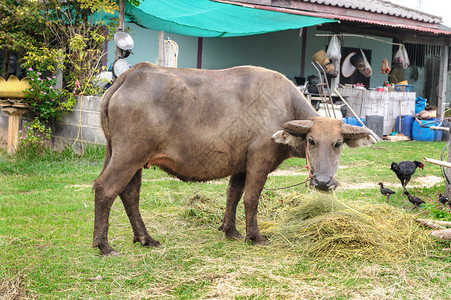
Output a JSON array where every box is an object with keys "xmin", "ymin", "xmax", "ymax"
[{"xmin": 108, "ymin": 24, "xmax": 392, "ymax": 88}]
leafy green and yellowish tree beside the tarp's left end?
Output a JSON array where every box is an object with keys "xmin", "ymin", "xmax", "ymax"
[{"xmin": 0, "ymin": 0, "xmax": 118, "ymax": 121}]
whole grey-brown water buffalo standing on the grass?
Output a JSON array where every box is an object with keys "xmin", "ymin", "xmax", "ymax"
[{"xmin": 93, "ymin": 63, "xmax": 369, "ymax": 255}]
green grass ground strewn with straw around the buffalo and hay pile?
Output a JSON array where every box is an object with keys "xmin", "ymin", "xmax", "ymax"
[{"xmin": 0, "ymin": 142, "xmax": 451, "ymax": 299}]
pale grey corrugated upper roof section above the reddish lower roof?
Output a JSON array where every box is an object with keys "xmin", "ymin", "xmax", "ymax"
[{"xmin": 298, "ymin": 0, "xmax": 442, "ymax": 24}]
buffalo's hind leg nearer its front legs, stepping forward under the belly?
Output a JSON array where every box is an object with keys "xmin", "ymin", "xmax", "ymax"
[{"xmin": 119, "ymin": 169, "xmax": 160, "ymax": 247}]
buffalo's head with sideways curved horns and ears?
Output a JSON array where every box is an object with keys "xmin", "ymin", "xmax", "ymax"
[{"xmin": 273, "ymin": 117, "xmax": 372, "ymax": 191}]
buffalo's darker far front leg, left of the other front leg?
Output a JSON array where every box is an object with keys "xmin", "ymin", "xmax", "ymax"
[{"xmin": 219, "ymin": 173, "xmax": 246, "ymax": 239}]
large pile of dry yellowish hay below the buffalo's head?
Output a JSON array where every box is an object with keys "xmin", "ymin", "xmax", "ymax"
[{"xmin": 263, "ymin": 194, "xmax": 434, "ymax": 260}]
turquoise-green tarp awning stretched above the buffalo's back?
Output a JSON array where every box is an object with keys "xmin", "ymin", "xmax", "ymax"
[{"xmin": 101, "ymin": 0, "xmax": 336, "ymax": 37}]
